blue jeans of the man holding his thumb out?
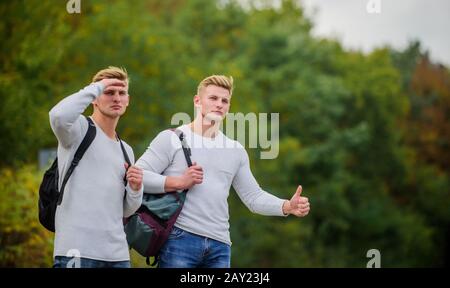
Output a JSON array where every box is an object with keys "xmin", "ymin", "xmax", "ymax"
[{"xmin": 158, "ymin": 227, "xmax": 231, "ymax": 268}]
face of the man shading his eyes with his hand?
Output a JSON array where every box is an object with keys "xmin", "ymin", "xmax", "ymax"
[{"xmin": 92, "ymin": 82, "xmax": 130, "ymax": 118}]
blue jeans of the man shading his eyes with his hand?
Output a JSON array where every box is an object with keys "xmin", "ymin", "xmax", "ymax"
[{"xmin": 53, "ymin": 256, "xmax": 131, "ymax": 268}]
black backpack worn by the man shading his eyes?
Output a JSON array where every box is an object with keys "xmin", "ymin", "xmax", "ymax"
[{"xmin": 39, "ymin": 116, "xmax": 97, "ymax": 232}]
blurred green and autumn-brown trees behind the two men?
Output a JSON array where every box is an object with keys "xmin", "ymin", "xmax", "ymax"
[{"xmin": 0, "ymin": 0, "xmax": 450, "ymax": 267}]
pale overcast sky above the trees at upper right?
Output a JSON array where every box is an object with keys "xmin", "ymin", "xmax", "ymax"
[{"xmin": 302, "ymin": 0, "xmax": 450, "ymax": 67}]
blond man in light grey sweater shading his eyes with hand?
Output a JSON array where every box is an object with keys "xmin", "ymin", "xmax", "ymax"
[{"xmin": 49, "ymin": 67, "xmax": 143, "ymax": 268}]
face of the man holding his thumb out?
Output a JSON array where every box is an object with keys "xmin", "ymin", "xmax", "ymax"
[{"xmin": 194, "ymin": 85, "xmax": 231, "ymax": 122}]
